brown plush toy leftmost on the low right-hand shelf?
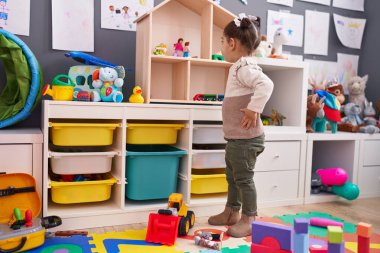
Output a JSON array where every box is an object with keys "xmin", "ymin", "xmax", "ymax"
[{"xmin": 306, "ymin": 94, "xmax": 325, "ymax": 133}]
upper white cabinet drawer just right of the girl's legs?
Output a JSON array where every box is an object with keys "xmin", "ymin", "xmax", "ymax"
[{"xmin": 255, "ymin": 141, "xmax": 301, "ymax": 171}]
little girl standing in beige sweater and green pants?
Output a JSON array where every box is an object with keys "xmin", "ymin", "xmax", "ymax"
[{"xmin": 208, "ymin": 14, "xmax": 273, "ymax": 237}]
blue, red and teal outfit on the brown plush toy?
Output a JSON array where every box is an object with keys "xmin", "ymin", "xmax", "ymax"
[{"xmin": 312, "ymin": 90, "xmax": 341, "ymax": 134}]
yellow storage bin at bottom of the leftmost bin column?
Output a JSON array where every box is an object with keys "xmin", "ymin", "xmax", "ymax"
[{"xmin": 50, "ymin": 173, "xmax": 117, "ymax": 204}]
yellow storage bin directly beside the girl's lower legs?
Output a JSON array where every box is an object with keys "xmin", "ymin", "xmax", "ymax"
[{"xmin": 191, "ymin": 169, "xmax": 228, "ymax": 194}]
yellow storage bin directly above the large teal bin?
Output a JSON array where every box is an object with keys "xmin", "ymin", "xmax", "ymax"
[{"xmin": 127, "ymin": 123, "xmax": 185, "ymax": 144}]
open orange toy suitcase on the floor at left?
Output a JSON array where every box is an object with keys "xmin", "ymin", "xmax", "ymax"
[{"xmin": 0, "ymin": 173, "xmax": 62, "ymax": 253}]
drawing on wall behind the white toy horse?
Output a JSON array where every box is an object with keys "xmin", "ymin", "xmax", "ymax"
[{"xmin": 267, "ymin": 10, "xmax": 303, "ymax": 47}]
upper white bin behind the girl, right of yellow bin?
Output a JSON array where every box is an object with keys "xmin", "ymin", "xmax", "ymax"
[{"xmin": 193, "ymin": 124, "xmax": 226, "ymax": 144}]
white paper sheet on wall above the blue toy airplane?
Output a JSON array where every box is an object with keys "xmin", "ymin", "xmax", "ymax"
[{"xmin": 52, "ymin": 0, "xmax": 94, "ymax": 52}]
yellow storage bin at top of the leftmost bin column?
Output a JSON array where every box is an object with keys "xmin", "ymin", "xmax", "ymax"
[{"xmin": 50, "ymin": 123, "xmax": 120, "ymax": 146}]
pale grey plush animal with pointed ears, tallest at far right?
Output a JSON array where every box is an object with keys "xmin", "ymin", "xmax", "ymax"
[{"xmin": 347, "ymin": 75, "xmax": 368, "ymax": 116}]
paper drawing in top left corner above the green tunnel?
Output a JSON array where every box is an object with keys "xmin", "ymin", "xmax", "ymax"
[{"xmin": 0, "ymin": 0, "xmax": 30, "ymax": 36}]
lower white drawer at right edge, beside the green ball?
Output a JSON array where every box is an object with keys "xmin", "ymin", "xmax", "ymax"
[{"xmin": 358, "ymin": 166, "xmax": 380, "ymax": 194}]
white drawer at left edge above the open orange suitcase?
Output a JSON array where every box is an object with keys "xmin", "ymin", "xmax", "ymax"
[{"xmin": 0, "ymin": 144, "xmax": 33, "ymax": 174}]
